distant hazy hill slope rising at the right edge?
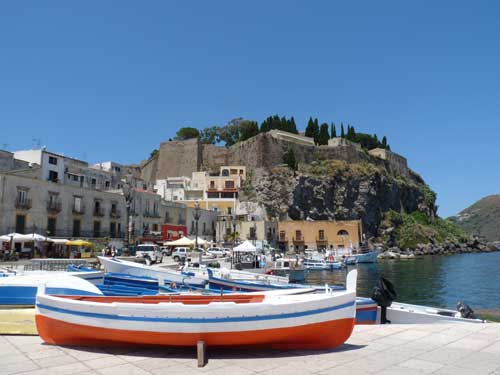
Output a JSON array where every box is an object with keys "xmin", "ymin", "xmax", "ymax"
[{"xmin": 450, "ymin": 194, "xmax": 500, "ymax": 241}]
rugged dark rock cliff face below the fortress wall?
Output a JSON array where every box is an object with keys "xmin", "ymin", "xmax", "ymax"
[{"xmin": 256, "ymin": 162, "xmax": 435, "ymax": 238}]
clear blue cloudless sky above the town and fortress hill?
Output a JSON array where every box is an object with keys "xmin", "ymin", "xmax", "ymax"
[{"xmin": 0, "ymin": 0, "xmax": 500, "ymax": 217}]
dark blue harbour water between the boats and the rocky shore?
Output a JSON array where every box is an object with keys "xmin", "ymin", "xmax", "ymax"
[{"xmin": 306, "ymin": 252, "xmax": 500, "ymax": 309}]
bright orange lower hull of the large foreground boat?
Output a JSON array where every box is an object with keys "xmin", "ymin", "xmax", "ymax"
[{"xmin": 36, "ymin": 315, "xmax": 354, "ymax": 350}]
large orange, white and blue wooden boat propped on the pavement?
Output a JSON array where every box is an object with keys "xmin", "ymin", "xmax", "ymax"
[{"xmin": 36, "ymin": 270, "xmax": 357, "ymax": 349}]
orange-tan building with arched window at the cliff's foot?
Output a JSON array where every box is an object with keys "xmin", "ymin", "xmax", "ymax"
[{"xmin": 278, "ymin": 220, "xmax": 362, "ymax": 252}]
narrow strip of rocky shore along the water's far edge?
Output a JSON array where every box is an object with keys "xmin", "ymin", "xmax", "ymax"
[{"xmin": 379, "ymin": 239, "xmax": 500, "ymax": 259}]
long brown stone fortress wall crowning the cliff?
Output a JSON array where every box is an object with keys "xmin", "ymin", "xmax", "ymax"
[{"xmin": 141, "ymin": 130, "xmax": 410, "ymax": 181}]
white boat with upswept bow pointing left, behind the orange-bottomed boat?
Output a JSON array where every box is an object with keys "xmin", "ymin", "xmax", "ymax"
[{"xmin": 97, "ymin": 256, "xmax": 206, "ymax": 287}]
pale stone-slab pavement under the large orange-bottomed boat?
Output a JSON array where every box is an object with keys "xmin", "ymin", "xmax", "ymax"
[{"xmin": 0, "ymin": 323, "xmax": 500, "ymax": 375}]
